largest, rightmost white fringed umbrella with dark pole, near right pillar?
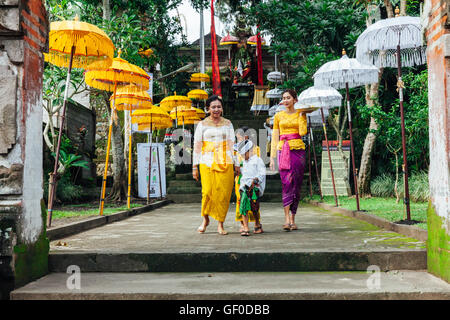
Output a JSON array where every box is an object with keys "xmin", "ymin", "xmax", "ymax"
[{"xmin": 356, "ymin": 8, "xmax": 426, "ymax": 220}]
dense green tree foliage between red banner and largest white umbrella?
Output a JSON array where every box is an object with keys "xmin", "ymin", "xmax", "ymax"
[{"xmin": 246, "ymin": 0, "xmax": 365, "ymax": 91}]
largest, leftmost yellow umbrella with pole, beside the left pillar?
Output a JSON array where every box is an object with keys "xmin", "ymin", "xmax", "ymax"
[{"xmin": 44, "ymin": 16, "xmax": 115, "ymax": 227}]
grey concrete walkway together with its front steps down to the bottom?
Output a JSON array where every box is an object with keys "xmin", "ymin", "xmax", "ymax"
[{"xmin": 11, "ymin": 203, "xmax": 450, "ymax": 300}]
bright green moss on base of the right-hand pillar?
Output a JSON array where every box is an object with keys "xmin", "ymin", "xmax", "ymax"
[{"xmin": 427, "ymin": 201, "xmax": 450, "ymax": 282}]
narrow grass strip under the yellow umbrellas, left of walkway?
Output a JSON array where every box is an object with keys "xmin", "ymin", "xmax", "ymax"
[{"xmin": 53, "ymin": 203, "xmax": 142, "ymax": 219}]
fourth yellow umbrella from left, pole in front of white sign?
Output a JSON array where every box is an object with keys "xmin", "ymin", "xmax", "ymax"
[{"xmin": 131, "ymin": 106, "xmax": 172, "ymax": 204}]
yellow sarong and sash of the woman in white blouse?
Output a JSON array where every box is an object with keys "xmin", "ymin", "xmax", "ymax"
[{"xmin": 200, "ymin": 141, "xmax": 234, "ymax": 222}]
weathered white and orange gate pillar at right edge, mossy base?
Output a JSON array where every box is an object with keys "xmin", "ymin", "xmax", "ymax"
[{"xmin": 422, "ymin": 0, "xmax": 450, "ymax": 282}]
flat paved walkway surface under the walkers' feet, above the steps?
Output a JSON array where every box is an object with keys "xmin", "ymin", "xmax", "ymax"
[{"xmin": 51, "ymin": 203, "xmax": 425, "ymax": 253}]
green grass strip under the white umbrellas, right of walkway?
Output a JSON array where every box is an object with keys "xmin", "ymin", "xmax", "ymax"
[{"xmin": 306, "ymin": 195, "xmax": 428, "ymax": 230}]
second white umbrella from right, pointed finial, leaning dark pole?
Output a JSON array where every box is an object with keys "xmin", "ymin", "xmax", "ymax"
[{"xmin": 313, "ymin": 50, "xmax": 379, "ymax": 211}]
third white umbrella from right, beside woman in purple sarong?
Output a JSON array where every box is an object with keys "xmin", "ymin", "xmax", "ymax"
[{"xmin": 298, "ymin": 86, "xmax": 342, "ymax": 206}]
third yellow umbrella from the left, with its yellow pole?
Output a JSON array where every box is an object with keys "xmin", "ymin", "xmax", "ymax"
[{"xmin": 111, "ymin": 85, "xmax": 153, "ymax": 209}]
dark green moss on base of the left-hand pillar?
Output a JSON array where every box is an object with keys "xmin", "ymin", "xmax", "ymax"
[{"xmin": 14, "ymin": 200, "xmax": 50, "ymax": 288}]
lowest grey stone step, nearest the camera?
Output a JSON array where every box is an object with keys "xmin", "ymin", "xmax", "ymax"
[{"xmin": 10, "ymin": 269, "xmax": 450, "ymax": 300}]
